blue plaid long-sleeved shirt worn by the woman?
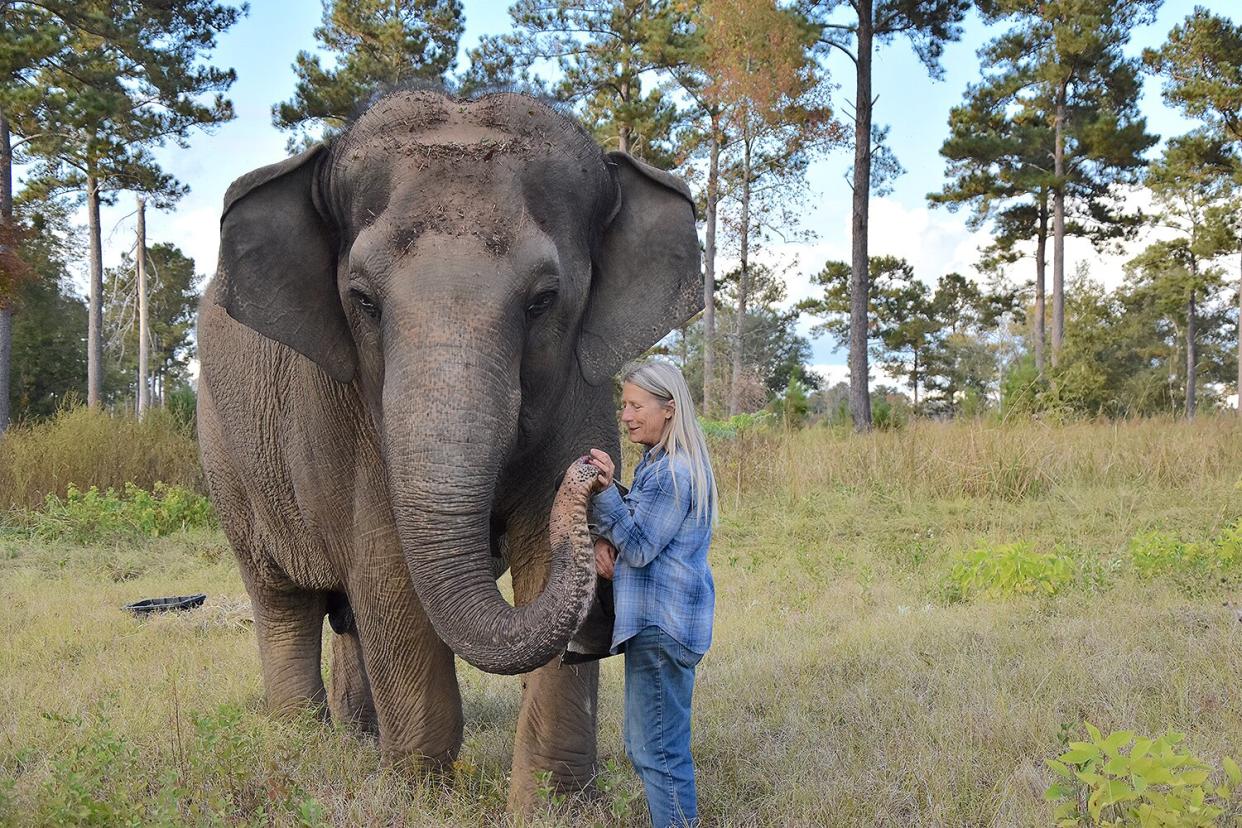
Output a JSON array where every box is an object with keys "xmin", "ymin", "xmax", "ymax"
[{"xmin": 591, "ymin": 448, "xmax": 715, "ymax": 654}]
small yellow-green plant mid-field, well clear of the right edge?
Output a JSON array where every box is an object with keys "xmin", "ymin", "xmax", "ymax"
[{"xmin": 945, "ymin": 542, "xmax": 1074, "ymax": 601}]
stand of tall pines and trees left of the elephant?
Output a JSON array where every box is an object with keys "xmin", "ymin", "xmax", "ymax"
[{"xmin": 0, "ymin": 0, "xmax": 245, "ymax": 431}]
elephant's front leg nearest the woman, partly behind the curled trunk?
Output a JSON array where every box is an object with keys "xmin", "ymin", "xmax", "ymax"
[{"xmin": 509, "ymin": 531, "xmax": 600, "ymax": 813}]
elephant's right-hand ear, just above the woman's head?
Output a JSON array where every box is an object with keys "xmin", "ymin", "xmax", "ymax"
[{"xmin": 578, "ymin": 153, "xmax": 703, "ymax": 385}]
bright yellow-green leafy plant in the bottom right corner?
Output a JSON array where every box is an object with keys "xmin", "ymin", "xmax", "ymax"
[{"xmin": 1043, "ymin": 721, "xmax": 1242, "ymax": 828}]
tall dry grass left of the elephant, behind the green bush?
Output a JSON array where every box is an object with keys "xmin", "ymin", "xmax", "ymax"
[{"xmin": 0, "ymin": 407, "xmax": 204, "ymax": 509}]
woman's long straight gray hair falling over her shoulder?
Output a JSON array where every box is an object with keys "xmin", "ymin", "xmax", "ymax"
[{"xmin": 621, "ymin": 360, "xmax": 717, "ymax": 525}]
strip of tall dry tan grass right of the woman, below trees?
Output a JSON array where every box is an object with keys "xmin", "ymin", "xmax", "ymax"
[{"xmin": 712, "ymin": 415, "xmax": 1242, "ymax": 508}]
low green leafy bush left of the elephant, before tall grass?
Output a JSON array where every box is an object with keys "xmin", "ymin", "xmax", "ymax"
[{"xmin": 17, "ymin": 483, "xmax": 216, "ymax": 544}]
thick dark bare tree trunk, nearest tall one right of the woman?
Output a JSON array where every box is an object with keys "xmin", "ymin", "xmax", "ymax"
[{"xmin": 850, "ymin": 0, "xmax": 874, "ymax": 431}]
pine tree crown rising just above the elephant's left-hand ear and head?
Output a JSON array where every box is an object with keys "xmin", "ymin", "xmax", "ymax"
[{"xmin": 272, "ymin": 0, "xmax": 465, "ymax": 149}]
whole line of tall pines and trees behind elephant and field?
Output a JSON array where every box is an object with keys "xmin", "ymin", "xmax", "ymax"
[{"xmin": 0, "ymin": 0, "xmax": 1242, "ymax": 428}]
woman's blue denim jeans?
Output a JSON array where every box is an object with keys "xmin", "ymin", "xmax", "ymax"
[{"xmin": 625, "ymin": 626, "xmax": 703, "ymax": 828}]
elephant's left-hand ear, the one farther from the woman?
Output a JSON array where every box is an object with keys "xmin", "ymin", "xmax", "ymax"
[{"xmin": 215, "ymin": 145, "xmax": 358, "ymax": 382}]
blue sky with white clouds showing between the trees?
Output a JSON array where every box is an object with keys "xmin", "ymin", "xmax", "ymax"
[{"xmin": 72, "ymin": 0, "xmax": 1236, "ymax": 380}]
